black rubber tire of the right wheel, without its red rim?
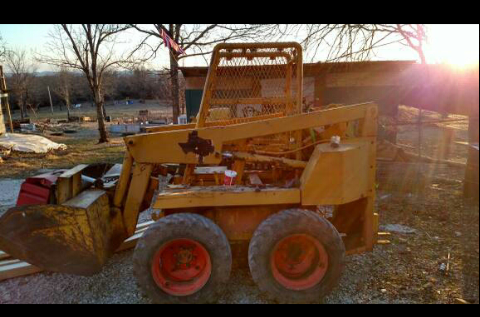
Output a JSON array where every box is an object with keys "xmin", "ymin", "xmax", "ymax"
[{"xmin": 248, "ymin": 209, "xmax": 345, "ymax": 303}]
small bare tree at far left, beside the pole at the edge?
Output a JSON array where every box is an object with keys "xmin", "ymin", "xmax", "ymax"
[{"xmin": 5, "ymin": 49, "xmax": 36, "ymax": 119}]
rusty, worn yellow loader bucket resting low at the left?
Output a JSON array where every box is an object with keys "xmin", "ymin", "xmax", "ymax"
[{"xmin": 0, "ymin": 190, "xmax": 125, "ymax": 276}]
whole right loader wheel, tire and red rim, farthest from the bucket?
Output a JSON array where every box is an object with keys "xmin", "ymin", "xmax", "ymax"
[{"xmin": 248, "ymin": 209, "xmax": 345, "ymax": 303}]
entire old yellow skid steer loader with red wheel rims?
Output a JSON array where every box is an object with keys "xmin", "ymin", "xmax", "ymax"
[{"xmin": 0, "ymin": 43, "xmax": 377, "ymax": 303}]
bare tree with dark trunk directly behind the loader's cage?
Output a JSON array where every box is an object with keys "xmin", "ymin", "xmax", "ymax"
[{"xmin": 131, "ymin": 24, "xmax": 267, "ymax": 123}]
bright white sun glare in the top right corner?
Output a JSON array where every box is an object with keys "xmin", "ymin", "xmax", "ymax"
[{"xmin": 425, "ymin": 24, "xmax": 479, "ymax": 68}]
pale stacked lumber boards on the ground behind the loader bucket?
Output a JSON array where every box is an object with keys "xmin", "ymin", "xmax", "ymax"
[{"xmin": 0, "ymin": 221, "xmax": 154, "ymax": 281}]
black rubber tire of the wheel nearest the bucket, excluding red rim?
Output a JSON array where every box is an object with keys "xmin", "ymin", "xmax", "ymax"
[{"xmin": 133, "ymin": 213, "xmax": 232, "ymax": 304}]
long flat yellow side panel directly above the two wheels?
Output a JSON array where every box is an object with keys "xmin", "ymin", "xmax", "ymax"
[{"xmin": 153, "ymin": 186, "xmax": 300, "ymax": 209}]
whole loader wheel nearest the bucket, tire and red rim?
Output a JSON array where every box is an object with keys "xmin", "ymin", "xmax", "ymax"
[{"xmin": 133, "ymin": 213, "xmax": 232, "ymax": 304}]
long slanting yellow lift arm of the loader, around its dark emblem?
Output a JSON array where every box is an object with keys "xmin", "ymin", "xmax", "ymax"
[{"xmin": 125, "ymin": 103, "xmax": 375, "ymax": 164}]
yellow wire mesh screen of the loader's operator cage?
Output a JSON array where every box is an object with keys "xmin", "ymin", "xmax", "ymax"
[{"xmin": 202, "ymin": 43, "xmax": 302, "ymax": 123}]
